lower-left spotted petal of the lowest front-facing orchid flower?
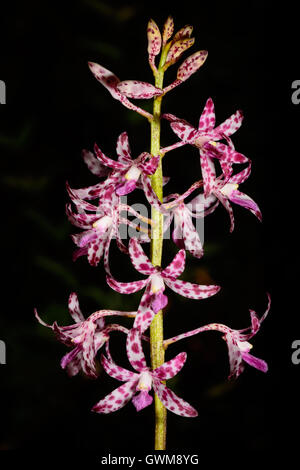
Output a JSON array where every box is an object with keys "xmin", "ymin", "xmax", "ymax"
[{"xmin": 92, "ymin": 379, "xmax": 138, "ymax": 414}]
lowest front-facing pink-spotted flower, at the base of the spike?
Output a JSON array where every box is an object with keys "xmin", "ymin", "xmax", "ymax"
[{"xmin": 92, "ymin": 328, "xmax": 198, "ymax": 417}]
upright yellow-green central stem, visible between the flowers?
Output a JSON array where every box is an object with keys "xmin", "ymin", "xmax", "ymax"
[{"xmin": 150, "ymin": 50, "xmax": 167, "ymax": 450}]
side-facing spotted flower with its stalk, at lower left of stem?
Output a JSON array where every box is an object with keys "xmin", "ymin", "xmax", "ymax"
[{"xmin": 35, "ymin": 292, "xmax": 136, "ymax": 378}]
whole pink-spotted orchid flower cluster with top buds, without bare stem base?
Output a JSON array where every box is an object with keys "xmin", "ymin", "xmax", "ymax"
[{"xmin": 35, "ymin": 13, "xmax": 270, "ymax": 448}]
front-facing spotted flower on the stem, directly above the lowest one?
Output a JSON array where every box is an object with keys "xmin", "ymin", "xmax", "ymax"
[{"xmin": 106, "ymin": 238, "xmax": 220, "ymax": 331}]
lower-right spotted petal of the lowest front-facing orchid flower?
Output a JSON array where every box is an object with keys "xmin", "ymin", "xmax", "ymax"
[{"xmin": 153, "ymin": 379, "xmax": 198, "ymax": 418}]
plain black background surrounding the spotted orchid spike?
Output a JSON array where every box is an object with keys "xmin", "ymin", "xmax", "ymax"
[{"xmin": 0, "ymin": 0, "xmax": 300, "ymax": 462}]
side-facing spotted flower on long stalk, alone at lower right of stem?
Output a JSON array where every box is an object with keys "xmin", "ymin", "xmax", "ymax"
[{"xmin": 164, "ymin": 294, "xmax": 271, "ymax": 379}]
